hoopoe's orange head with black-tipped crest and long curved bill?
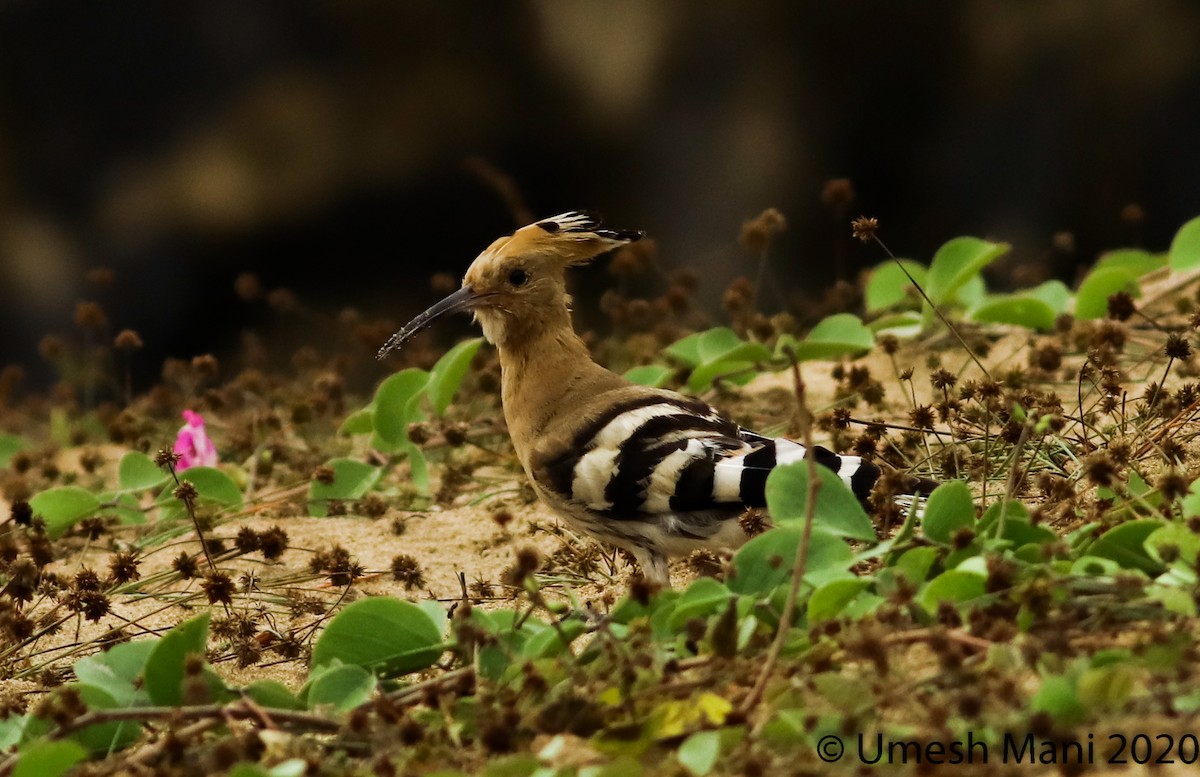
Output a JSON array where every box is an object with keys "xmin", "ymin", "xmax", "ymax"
[{"xmin": 379, "ymin": 211, "xmax": 642, "ymax": 359}]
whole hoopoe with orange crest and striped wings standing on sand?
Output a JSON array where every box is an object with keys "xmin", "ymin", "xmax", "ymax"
[{"xmin": 379, "ymin": 212, "xmax": 926, "ymax": 586}]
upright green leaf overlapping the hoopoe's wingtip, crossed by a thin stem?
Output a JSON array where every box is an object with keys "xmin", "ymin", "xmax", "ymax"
[{"xmin": 767, "ymin": 462, "xmax": 877, "ymax": 542}]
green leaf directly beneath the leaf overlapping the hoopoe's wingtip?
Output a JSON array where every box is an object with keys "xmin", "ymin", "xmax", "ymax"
[{"xmin": 726, "ymin": 526, "xmax": 854, "ymax": 596}]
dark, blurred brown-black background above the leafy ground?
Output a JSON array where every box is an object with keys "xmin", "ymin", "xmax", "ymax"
[{"xmin": 0, "ymin": 0, "xmax": 1200, "ymax": 388}]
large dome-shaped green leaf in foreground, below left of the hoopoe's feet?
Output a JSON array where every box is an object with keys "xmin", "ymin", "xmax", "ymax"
[{"xmin": 312, "ymin": 597, "xmax": 445, "ymax": 677}]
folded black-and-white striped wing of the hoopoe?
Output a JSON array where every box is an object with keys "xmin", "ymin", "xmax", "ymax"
[{"xmin": 532, "ymin": 393, "xmax": 878, "ymax": 519}]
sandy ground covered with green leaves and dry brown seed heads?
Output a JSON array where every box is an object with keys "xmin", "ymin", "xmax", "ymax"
[{"xmin": 0, "ymin": 215, "xmax": 1200, "ymax": 777}]
